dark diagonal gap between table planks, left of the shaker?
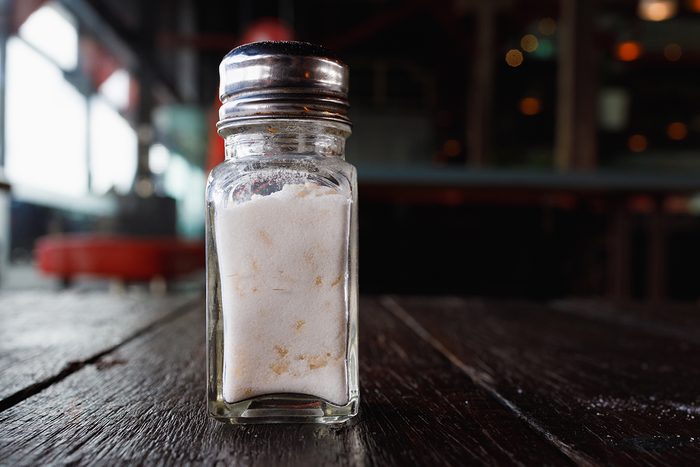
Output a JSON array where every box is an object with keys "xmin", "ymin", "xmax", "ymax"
[{"xmin": 0, "ymin": 296, "xmax": 202, "ymax": 412}]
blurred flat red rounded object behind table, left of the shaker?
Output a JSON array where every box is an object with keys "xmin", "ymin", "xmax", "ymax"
[{"xmin": 35, "ymin": 234, "xmax": 204, "ymax": 281}]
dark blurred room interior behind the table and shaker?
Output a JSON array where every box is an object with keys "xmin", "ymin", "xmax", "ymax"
[{"xmin": 0, "ymin": 0, "xmax": 700, "ymax": 301}]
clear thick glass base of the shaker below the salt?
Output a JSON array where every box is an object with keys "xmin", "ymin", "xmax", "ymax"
[{"xmin": 209, "ymin": 394, "xmax": 360, "ymax": 425}]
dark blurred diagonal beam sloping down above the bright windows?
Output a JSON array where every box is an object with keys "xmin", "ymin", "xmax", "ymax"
[{"xmin": 59, "ymin": 0, "xmax": 182, "ymax": 102}]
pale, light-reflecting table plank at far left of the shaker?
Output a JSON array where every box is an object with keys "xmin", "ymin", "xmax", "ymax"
[{"xmin": 0, "ymin": 291, "xmax": 196, "ymax": 409}]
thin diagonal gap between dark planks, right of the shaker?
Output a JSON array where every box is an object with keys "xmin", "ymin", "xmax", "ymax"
[{"xmin": 379, "ymin": 295, "xmax": 596, "ymax": 466}]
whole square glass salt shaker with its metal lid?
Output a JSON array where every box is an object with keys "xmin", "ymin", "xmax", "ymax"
[{"xmin": 206, "ymin": 42, "xmax": 359, "ymax": 423}]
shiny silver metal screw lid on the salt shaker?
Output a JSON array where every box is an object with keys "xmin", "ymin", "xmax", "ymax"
[{"xmin": 217, "ymin": 42, "xmax": 350, "ymax": 134}]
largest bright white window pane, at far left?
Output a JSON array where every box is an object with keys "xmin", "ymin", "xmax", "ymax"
[{"xmin": 5, "ymin": 37, "xmax": 88, "ymax": 195}]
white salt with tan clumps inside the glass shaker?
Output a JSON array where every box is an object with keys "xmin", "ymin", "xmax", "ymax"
[{"xmin": 215, "ymin": 183, "xmax": 350, "ymax": 405}]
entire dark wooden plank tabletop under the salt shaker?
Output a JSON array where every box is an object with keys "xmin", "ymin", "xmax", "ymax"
[{"xmin": 0, "ymin": 292, "xmax": 700, "ymax": 466}]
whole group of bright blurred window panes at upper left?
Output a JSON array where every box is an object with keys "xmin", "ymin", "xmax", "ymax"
[{"xmin": 5, "ymin": 2, "xmax": 137, "ymax": 201}]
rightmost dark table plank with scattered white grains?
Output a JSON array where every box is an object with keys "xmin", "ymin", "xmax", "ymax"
[{"xmin": 383, "ymin": 298, "xmax": 700, "ymax": 465}]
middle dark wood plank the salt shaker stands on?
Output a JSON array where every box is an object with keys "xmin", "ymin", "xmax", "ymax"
[{"xmin": 0, "ymin": 299, "xmax": 571, "ymax": 466}]
